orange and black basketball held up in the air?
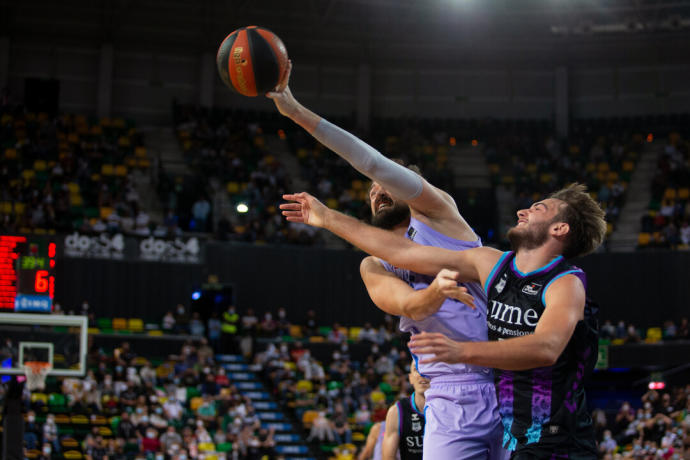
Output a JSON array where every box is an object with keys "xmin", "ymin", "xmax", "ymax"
[{"xmin": 216, "ymin": 26, "xmax": 288, "ymax": 97}]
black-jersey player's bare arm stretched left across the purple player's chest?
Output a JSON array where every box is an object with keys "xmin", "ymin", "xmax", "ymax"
[{"xmin": 280, "ymin": 192, "xmax": 502, "ymax": 283}]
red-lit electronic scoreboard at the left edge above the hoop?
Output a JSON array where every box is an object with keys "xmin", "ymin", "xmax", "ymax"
[{"xmin": 0, "ymin": 235, "xmax": 56, "ymax": 312}]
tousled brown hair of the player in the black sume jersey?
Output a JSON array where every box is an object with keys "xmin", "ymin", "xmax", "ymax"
[{"xmin": 549, "ymin": 183, "xmax": 606, "ymax": 259}]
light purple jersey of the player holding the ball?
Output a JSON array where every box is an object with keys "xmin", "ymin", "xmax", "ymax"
[{"xmin": 382, "ymin": 218, "xmax": 492, "ymax": 380}]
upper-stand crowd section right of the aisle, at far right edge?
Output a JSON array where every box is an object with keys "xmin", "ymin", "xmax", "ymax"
[{"xmin": 638, "ymin": 132, "xmax": 690, "ymax": 249}]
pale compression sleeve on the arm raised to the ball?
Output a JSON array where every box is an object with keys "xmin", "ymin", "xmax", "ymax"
[{"xmin": 313, "ymin": 118, "xmax": 424, "ymax": 200}]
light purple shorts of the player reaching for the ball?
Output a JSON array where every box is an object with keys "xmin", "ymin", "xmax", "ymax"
[{"xmin": 423, "ymin": 373, "xmax": 510, "ymax": 460}]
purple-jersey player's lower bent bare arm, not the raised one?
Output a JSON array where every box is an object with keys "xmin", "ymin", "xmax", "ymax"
[{"xmin": 359, "ymin": 256, "xmax": 474, "ymax": 321}]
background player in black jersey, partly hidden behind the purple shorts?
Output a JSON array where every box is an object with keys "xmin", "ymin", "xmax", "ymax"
[{"xmin": 382, "ymin": 361, "xmax": 429, "ymax": 460}]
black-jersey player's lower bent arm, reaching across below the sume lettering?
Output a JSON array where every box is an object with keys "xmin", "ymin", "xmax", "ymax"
[{"xmin": 410, "ymin": 275, "xmax": 585, "ymax": 371}]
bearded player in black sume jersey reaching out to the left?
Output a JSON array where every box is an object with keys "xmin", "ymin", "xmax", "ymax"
[{"xmin": 281, "ymin": 184, "xmax": 606, "ymax": 460}]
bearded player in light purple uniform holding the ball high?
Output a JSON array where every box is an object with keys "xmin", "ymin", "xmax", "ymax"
[{"xmin": 268, "ymin": 64, "xmax": 505, "ymax": 460}]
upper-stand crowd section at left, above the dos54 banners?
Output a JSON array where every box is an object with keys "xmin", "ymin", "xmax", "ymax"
[{"xmin": 0, "ymin": 105, "xmax": 168, "ymax": 236}]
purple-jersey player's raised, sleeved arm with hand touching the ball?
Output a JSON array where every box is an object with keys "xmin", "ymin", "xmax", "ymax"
[{"xmin": 266, "ymin": 63, "xmax": 456, "ymax": 219}]
